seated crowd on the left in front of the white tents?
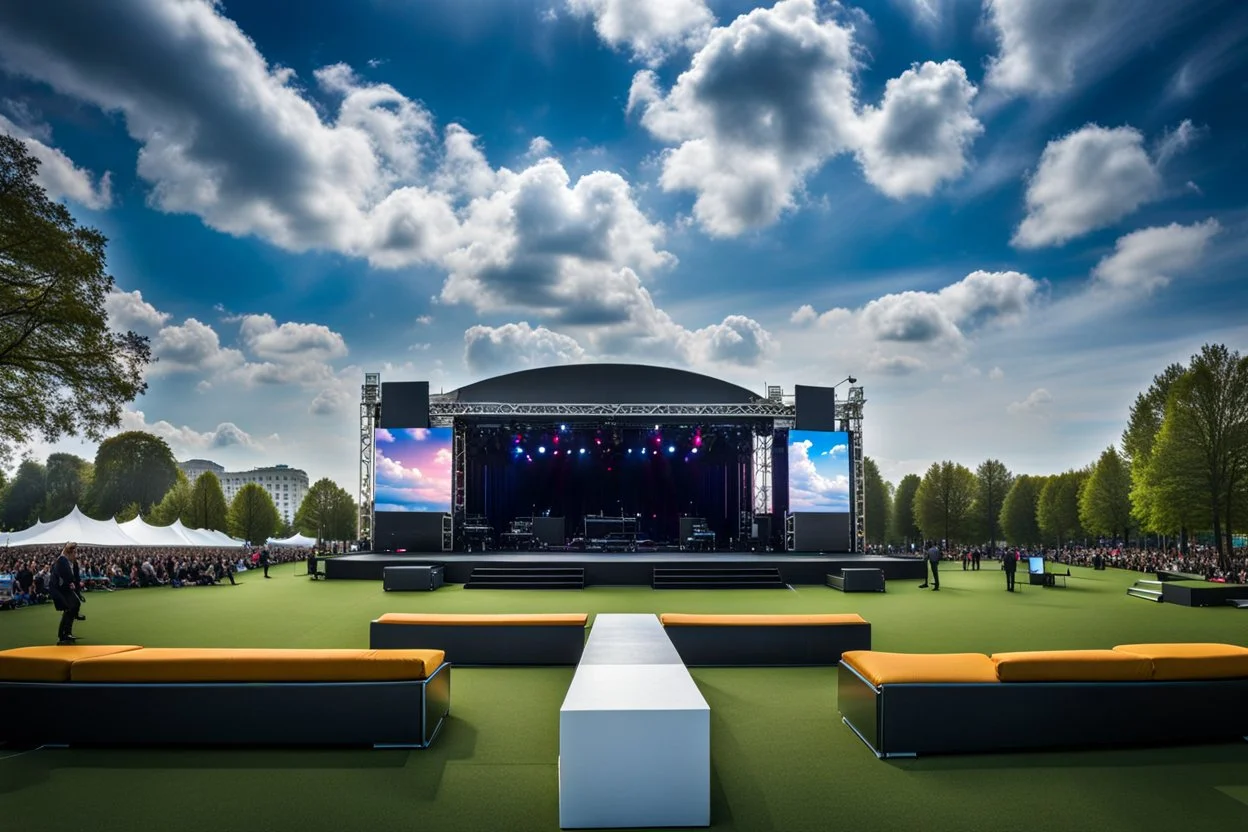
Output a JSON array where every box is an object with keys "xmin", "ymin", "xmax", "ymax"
[{"xmin": 0, "ymin": 545, "xmax": 307, "ymax": 609}]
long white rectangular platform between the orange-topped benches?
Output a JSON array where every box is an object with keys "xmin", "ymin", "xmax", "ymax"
[{"xmin": 559, "ymin": 615, "xmax": 710, "ymax": 830}]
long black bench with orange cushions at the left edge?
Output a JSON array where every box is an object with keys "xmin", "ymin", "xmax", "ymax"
[{"xmin": 0, "ymin": 645, "xmax": 451, "ymax": 748}]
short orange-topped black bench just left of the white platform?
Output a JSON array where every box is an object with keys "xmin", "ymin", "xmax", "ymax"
[{"xmin": 368, "ymin": 612, "xmax": 589, "ymax": 666}]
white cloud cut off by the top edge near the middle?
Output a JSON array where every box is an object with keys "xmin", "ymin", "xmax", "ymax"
[{"xmin": 567, "ymin": 0, "xmax": 715, "ymax": 66}]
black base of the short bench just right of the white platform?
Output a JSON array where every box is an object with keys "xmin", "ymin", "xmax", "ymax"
[{"xmin": 665, "ymin": 624, "xmax": 871, "ymax": 667}]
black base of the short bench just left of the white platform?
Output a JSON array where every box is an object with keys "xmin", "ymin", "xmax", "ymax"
[{"xmin": 368, "ymin": 621, "xmax": 585, "ymax": 666}]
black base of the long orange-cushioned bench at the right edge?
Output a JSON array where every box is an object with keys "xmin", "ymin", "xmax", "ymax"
[{"xmin": 837, "ymin": 665, "xmax": 1248, "ymax": 757}]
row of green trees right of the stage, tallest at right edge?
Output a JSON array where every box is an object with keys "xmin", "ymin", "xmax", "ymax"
[{"xmin": 864, "ymin": 344, "xmax": 1248, "ymax": 573}]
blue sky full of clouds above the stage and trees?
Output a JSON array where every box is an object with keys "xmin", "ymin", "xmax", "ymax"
[{"xmin": 0, "ymin": 0, "xmax": 1248, "ymax": 491}]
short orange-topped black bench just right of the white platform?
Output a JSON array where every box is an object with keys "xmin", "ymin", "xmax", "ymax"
[{"xmin": 659, "ymin": 612, "xmax": 871, "ymax": 667}]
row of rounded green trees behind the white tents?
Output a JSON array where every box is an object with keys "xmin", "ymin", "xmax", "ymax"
[{"xmin": 0, "ymin": 430, "xmax": 357, "ymax": 543}]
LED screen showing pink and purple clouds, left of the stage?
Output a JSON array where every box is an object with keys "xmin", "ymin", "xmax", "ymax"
[{"xmin": 373, "ymin": 428, "xmax": 452, "ymax": 511}]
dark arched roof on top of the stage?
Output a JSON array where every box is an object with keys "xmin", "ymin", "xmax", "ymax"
[{"xmin": 444, "ymin": 364, "xmax": 763, "ymax": 404}]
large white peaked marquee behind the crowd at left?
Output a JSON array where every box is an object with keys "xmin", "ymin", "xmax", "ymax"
[{"xmin": 0, "ymin": 505, "xmax": 243, "ymax": 549}]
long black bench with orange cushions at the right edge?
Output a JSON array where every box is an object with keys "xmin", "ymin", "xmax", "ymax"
[{"xmin": 837, "ymin": 644, "xmax": 1248, "ymax": 757}]
